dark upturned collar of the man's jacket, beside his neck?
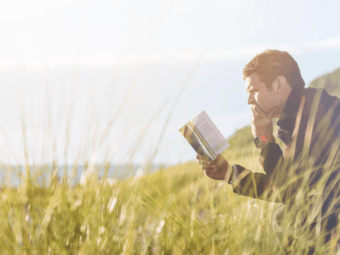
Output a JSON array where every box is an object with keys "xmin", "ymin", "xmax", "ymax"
[{"xmin": 276, "ymin": 88, "xmax": 305, "ymax": 145}]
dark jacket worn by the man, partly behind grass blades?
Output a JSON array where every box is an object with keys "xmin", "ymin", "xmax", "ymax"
[{"xmin": 233, "ymin": 88, "xmax": 340, "ymax": 236}]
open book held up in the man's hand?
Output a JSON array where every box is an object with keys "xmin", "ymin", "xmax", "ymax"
[{"xmin": 179, "ymin": 111, "xmax": 229, "ymax": 161}]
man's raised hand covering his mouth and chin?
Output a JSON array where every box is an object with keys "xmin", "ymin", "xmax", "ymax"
[{"xmin": 251, "ymin": 105, "xmax": 277, "ymax": 137}]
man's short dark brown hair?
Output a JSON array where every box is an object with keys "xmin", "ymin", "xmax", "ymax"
[{"xmin": 243, "ymin": 50, "xmax": 305, "ymax": 91}]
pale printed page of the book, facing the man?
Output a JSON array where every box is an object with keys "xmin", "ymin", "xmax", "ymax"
[{"xmin": 191, "ymin": 111, "xmax": 229, "ymax": 157}]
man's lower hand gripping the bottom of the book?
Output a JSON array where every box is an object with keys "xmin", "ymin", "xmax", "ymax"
[{"xmin": 196, "ymin": 154, "xmax": 230, "ymax": 180}]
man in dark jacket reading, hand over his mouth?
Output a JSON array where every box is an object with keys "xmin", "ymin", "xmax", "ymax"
[{"xmin": 197, "ymin": 50, "xmax": 340, "ymax": 253}]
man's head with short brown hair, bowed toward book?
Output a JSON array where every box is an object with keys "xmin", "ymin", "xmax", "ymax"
[{"xmin": 243, "ymin": 50, "xmax": 305, "ymax": 118}]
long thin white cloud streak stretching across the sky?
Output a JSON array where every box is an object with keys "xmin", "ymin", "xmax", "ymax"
[{"xmin": 0, "ymin": 37, "xmax": 340, "ymax": 71}]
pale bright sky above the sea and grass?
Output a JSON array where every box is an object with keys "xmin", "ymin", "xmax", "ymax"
[{"xmin": 0, "ymin": 0, "xmax": 340, "ymax": 164}]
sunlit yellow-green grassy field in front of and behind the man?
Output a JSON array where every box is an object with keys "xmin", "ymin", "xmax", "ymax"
[{"xmin": 0, "ymin": 122, "xmax": 338, "ymax": 254}]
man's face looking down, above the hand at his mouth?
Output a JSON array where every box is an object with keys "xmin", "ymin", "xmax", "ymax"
[{"xmin": 245, "ymin": 73, "xmax": 279, "ymax": 114}]
